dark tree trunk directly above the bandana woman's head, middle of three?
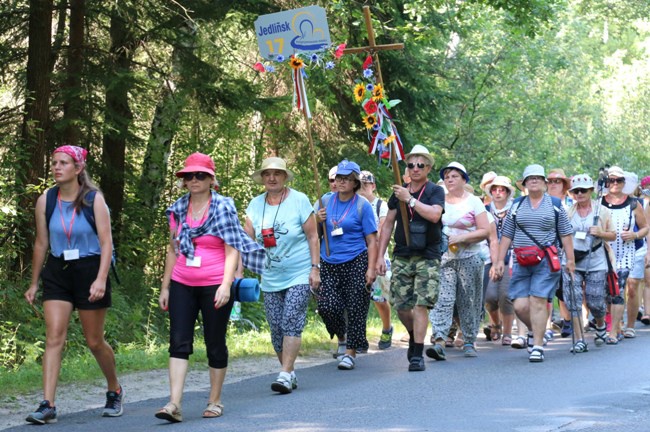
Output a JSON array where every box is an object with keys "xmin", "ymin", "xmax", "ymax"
[{"xmin": 63, "ymin": 0, "xmax": 86, "ymax": 145}]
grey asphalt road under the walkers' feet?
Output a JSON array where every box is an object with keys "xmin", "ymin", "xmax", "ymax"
[{"xmin": 7, "ymin": 327, "xmax": 650, "ymax": 432}]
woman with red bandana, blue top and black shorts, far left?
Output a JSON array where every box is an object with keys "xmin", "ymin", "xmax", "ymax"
[{"xmin": 25, "ymin": 145, "xmax": 124, "ymax": 424}]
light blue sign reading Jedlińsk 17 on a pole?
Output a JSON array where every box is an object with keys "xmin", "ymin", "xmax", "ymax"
[{"xmin": 255, "ymin": 6, "xmax": 331, "ymax": 60}]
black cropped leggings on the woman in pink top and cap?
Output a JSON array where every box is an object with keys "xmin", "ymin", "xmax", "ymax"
[{"xmin": 169, "ymin": 280, "xmax": 234, "ymax": 369}]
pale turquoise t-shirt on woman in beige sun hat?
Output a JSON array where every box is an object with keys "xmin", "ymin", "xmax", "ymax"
[{"xmin": 246, "ymin": 188, "xmax": 314, "ymax": 292}]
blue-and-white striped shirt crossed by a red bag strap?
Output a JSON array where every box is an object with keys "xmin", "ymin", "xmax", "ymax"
[{"xmin": 502, "ymin": 194, "xmax": 573, "ymax": 247}]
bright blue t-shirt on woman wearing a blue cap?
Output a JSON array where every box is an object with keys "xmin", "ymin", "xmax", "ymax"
[{"xmin": 320, "ymin": 192, "xmax": 377, "ymax": 264}]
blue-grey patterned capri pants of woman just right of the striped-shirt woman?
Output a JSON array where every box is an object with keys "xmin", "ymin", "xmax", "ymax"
[{"xmin": 562, "ymin": 269, "xmax": 607, "ymax": 319}]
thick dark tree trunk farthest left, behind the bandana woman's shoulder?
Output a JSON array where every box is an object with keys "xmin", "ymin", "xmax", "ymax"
[{"xmin": 15, "ymin": 0, "xmax": 52, "ymax": 270}]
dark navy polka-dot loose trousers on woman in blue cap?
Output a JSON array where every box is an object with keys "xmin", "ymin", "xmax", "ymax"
[{"xmin": 318, "ymin": 251, "xmax": 370, "ymax": 349}]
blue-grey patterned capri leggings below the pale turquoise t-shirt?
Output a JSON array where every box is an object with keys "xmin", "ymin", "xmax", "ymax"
[{"xmin": 264, "ymin": 284, "xmax": 309, "ymax": 353}]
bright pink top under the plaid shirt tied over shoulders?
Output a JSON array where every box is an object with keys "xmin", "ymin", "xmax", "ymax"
[{"xmin": 169, "ymin": 212, "xmax": 226, "ymax": 286}]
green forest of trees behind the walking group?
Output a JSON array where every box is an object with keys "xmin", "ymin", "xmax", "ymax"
[{"xmin": 0, "ymin": 0, "xmax": 650, "ymax": 369}]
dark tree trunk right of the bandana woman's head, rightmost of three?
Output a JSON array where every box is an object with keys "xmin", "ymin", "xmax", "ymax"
[{"xmin": 100, "ymin": 6, "xmax": 136, "ymax": 243}]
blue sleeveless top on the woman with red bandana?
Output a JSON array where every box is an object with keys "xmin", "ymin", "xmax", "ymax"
[{"xmin": 48, "ymin": 201, "xmax": 102, "ymax": 258}]
